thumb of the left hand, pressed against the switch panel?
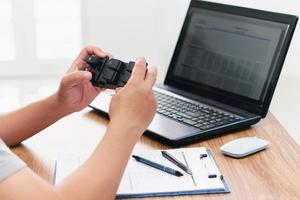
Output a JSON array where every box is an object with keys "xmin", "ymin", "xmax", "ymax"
[{"xmin": 61, "ymin": 71, "xmax": 92, "ymax": 87}]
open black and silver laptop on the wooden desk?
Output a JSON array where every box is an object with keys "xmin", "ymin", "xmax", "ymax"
[{"xmin": 90, "ymin": 0, "xmax": 298, "ymax": 146}]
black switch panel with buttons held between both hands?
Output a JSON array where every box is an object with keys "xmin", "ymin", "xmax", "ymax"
[{"xmin": 85, "ymin": 55, "xmax": 135, "ymax": 89}]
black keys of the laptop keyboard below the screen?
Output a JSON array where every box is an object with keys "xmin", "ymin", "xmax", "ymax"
[{"xmin": 154, "ymin": 91, "xmax": 242, "ymax": 130}]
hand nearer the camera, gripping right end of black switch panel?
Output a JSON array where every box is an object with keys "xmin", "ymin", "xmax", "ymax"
[{"xmin": 109, "ymin": 58, "xmax": 157, "ymax": 136}]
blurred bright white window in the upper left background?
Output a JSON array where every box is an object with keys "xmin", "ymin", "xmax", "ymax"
[{"xmin": 0, "ymin": 0, "xmax": 82, "ymax": 77}]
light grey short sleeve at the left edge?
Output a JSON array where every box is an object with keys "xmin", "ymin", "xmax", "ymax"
[{"xmin": 0, "ymin": 138, "xmax": 26, "ymax": 183}]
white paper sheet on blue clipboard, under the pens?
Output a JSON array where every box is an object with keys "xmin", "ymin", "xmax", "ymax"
[{"xmin": 55, "ymin": 147, "xmax": 225, "ymax": 195}]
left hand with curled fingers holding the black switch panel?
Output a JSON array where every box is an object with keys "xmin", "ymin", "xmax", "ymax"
[{"xmin": 55, "ymin": 46, "xmax": 111, "ymax": 114}]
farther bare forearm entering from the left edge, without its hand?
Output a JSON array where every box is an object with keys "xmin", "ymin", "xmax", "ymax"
[{"xmin": 0, "ymin": 95, "xmax": 67, "ymax": 146}]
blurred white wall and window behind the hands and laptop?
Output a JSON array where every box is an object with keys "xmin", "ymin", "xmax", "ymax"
[{"xmin": 0, "ymin": 0, "xmax": 300, "ymax": 81}]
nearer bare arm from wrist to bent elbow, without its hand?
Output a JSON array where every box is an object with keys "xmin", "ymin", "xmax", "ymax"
[{"xmin": 0, "ymin": 120, "xmax": 140, "ymax": 200}]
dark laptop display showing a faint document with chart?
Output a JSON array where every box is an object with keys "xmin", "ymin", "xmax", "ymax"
[{"xmin": 172, "ymin": 8, "xmax": 288, "ymax": 101}]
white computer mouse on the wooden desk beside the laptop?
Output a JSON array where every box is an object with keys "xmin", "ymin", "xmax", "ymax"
[{"xmin": 220, "ymin": 137, "xmax": 269, "ymax": 158}]
